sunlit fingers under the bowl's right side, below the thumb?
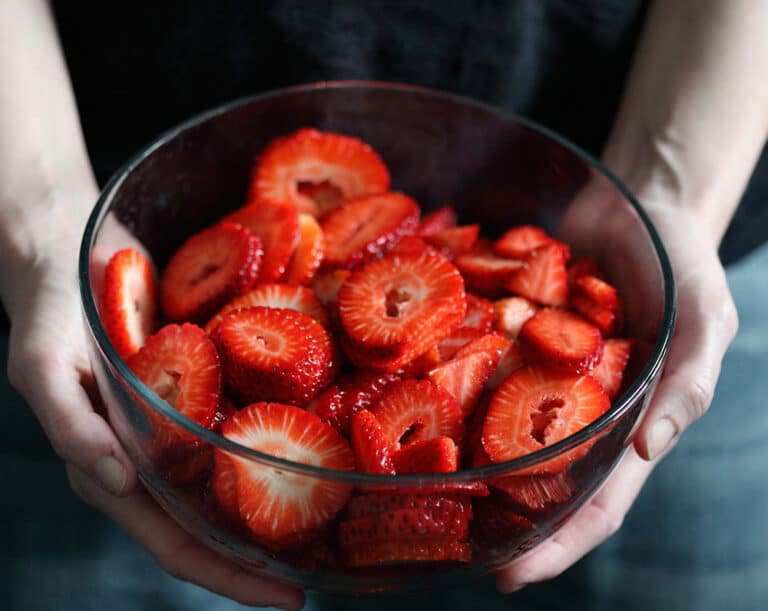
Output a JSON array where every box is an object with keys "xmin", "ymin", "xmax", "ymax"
[{"xmin": 496, "ymin": 448, "xmax": 653, "ymax": 593}]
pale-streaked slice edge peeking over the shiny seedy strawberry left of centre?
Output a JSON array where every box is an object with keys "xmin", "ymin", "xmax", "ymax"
[{"xmin": 205, "ymin": 284, "xmax": 328, "ymax": 333}]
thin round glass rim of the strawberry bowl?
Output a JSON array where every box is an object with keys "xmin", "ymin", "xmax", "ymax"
[{"xmin": 78, "ymin": 81, "xmax": 676, "ymax": 488}]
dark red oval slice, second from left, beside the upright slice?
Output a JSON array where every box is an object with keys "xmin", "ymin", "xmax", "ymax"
[{"xmin": 160, "ymin": 223, "xmax": 262, "ymax": 324}]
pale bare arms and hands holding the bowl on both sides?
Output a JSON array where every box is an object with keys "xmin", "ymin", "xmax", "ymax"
[{"xmin": 0, "ymin": 0, "xmax": 768, "ymax": 608}]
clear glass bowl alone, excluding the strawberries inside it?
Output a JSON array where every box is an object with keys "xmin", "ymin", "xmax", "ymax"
[{"xmin": 80, "ymin": 82, "xmax": 674, "ymax": 593}]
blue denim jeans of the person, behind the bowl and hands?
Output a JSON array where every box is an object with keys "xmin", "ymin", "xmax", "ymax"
[{"xmin": 0, "ymin": 241, "xmax": 768, "ymax": 611}]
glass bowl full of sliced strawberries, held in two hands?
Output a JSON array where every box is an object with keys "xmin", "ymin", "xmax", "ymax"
[{"xmin": 80, "ymin": 83, "xmax": 674, "ymax": 593}]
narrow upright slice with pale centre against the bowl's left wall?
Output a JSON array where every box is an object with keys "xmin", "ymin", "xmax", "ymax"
[{"xmin": 101, "ymin": 248, "xmax": 157, "ymax": 358}]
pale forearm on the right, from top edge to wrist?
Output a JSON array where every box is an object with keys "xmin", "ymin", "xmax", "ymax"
[{"xmin": 604, "ymin": 0, "xmax": 768, "ymax": 244}]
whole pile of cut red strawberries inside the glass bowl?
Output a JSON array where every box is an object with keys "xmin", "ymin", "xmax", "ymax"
[{"xmin": 101, "ymin": 129, "xmax": 633, "ymax": 567}]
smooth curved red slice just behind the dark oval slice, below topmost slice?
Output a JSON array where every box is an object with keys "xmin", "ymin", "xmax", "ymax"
[{"xmin": 224, "ymin": 202, "xmax": 299, "ymax": 282}]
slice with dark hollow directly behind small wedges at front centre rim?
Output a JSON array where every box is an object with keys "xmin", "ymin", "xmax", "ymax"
[{"xmin": 370, "ymin": 380, "xmax": 464, "ymax": 449}]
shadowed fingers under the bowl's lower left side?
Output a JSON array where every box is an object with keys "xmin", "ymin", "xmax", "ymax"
[{"xmin": 68, "ymin": 466, "xmax": 304, "ymax": 610}]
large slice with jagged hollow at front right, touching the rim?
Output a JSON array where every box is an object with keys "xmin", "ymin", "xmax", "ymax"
[{"xmin": 482, "ymin": 367, "xmax": 611, "ymax": 473}]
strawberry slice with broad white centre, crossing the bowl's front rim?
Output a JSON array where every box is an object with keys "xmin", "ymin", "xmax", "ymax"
[{"xmin": 216, "ymin": 403, "xmax": 354, "ymax": 547}]
